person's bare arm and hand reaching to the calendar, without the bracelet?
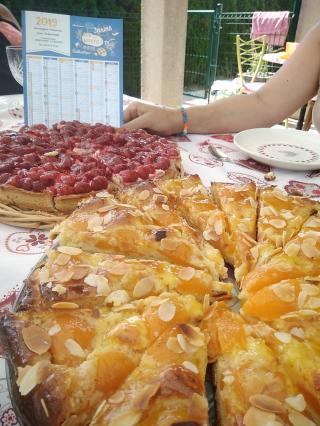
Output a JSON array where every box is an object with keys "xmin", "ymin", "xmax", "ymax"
[{"xmin": 124, "ymin": 23, "xmax": 320, "ymax": 135}]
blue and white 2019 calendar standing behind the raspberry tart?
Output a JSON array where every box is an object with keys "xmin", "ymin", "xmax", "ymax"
[{"xmin": 22, "ymin": 11, "xmax": 123, "ymax": 127}]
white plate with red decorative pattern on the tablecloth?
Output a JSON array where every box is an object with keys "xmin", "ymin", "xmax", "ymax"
[{"xmin": 234, "ymin": 129, "xmax": 320, "ymax": 170}]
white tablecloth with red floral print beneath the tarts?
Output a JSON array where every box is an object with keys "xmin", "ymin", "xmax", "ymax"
[{"xmin": 0, "ymin": 95, "xmax": 320, "ymax": 426}]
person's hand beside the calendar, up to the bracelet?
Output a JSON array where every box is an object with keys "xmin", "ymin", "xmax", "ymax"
[{"xmin": 123, "ymin": 102, "xmax": 183, "ymax": 136}]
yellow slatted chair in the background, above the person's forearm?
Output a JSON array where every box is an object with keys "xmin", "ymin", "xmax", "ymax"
[{"xmin": 236, "ymin": 34, "xmax": 267, "ymax": 93}]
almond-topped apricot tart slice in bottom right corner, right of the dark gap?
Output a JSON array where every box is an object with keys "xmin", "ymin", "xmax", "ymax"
[{"xmin": 202, "ymin": 305, "xmax": 320, "ymax": 426}]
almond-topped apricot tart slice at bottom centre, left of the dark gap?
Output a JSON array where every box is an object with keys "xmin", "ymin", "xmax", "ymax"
[{"xmin": 90, "ymin": 324, "xmax": 209, "ymax": 426}]
